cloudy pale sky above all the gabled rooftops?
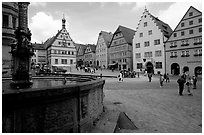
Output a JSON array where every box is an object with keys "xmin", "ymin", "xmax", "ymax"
[{"xmin": 28, "ymin": 0, "xmax": 202, "ymax": 44}]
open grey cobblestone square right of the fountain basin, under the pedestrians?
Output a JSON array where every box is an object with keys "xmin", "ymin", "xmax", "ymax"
[{"xmin": 104, "ymin": 75, "xmax": 202, "ymax": 133}]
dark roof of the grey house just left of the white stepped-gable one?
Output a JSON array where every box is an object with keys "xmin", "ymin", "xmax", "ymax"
[{"xmin": 109, "ymin": 25, "xmax": 136, "ymax": 47}]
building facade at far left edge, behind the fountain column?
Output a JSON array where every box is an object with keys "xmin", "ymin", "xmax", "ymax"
[{"xmin": 2, "ymin": 2, "xmax": 19, "ymax": 68}]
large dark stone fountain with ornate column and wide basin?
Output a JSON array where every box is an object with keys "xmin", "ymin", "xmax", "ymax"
[{"xmin": 2, "ymin": 2, "xmax": 105, "ymax": 133}]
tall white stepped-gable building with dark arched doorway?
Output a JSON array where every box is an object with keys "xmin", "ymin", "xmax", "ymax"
[{"xmin": 133, "ymin": 8, "xmax": 172, "ymax": 74}]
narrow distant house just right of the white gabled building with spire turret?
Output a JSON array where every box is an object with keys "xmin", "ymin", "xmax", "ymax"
[{"xmin": 76, "ymin": 44, "xmax": 86, "ymax": 67}]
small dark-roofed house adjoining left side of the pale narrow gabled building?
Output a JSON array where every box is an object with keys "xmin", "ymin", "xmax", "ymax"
[{"xmin": 84, "ymin": 44, "xmax": 96, "ymax": 67}]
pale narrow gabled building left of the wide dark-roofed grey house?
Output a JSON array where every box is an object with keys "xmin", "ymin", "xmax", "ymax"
[{"xmin": 96, "ymin": 31, "xmax": 113, "ymax": 68}]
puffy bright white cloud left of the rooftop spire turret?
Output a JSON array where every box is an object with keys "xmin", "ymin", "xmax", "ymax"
[{"xmin": 29, "ymin": 12, "xmax": 62, "ymax": 42}]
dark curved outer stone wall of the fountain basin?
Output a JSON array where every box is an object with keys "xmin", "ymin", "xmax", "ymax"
[{"xmin": 2, "ymin": 79, "xmax": 105, "ymax": 133}]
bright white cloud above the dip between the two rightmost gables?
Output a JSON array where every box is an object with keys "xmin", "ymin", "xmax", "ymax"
[{"xmin": 158, "ymin": 2, "xmax": 202, "ymax": 30}]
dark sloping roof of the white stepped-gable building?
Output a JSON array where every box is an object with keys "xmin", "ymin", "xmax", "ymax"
[{"xmin": 149, "ymin": 13, "xmax": 173, "ymax": 38}]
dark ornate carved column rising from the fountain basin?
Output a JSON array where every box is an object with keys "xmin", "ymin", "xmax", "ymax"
[{"xmin": 10, "ymin": 2, "xmax": 34, "ymax": 89}]
